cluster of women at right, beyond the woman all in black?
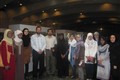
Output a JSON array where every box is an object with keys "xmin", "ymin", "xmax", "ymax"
[{"xmin": 68, "ymin": 32, "xmax": 120, "ymax": 80}]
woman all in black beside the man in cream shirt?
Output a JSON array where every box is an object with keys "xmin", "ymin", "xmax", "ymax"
[{"xmin": 57, "ymin": 34, "xmax": 69, "ymax": 78}]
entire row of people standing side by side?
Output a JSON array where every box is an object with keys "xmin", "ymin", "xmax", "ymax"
[{"xmin": 0, "ymin": 26, "xmax": 120, "ymax": 80}]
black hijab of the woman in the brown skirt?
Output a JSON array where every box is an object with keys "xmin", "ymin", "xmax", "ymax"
[{"xmin": 22, "ymin": 28, "xmax": 30, "ymax": 47}]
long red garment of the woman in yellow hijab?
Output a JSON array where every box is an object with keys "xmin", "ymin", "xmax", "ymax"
[{"xmin": 1, "ymin": 40, "xmax": 15, "ymax": 80}]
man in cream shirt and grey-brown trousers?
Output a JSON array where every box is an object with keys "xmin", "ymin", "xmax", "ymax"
[{"xmin": 45, "ymin": 29, "xmax": 57, "ymax": 75}]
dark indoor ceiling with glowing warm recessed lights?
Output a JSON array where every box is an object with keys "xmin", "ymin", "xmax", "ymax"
[{"xmin": 0, "ymin": 0, "xmax": 120, "ymax": 34}]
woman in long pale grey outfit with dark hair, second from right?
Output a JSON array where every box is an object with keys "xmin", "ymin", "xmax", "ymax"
[{"xmin": 97, "ymin": 37, "xmax": 110, "ymax": 80}]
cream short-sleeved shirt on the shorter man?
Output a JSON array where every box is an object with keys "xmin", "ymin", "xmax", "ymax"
[{"xmin": 45, "ymin": 36, "xmax": 57, "ymax": 49}]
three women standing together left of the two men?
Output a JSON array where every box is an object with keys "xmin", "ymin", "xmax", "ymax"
[{"xmin": 0, "ymin": 28, "xmax": 31, "ymax": 80}]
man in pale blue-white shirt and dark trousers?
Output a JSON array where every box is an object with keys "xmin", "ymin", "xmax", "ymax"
[{"xmin": 31, "ymin": 26, "xmax": 46, "ymax": 80}]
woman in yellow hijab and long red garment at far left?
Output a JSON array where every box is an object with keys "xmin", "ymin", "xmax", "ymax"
[{"xmin": 0, "ymin": 29, "xmax": 15, "ymax": 80}]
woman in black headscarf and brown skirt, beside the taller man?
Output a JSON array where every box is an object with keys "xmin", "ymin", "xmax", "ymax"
[{"xmin": 22, "ymin": 28, "xmax": 32, "ymax": 79}]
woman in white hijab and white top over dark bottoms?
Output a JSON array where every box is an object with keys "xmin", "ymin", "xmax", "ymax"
[{"xmin": 85, "ymin": 33, "xmax": 98, "ymax": 80}]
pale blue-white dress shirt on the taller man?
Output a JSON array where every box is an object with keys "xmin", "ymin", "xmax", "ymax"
[{"xmin": 31, "ymin": 34, "xmax": 46, "ymax": 52}]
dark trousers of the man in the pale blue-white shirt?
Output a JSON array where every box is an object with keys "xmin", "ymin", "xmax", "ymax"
[{"xmin": 32, "ymin": 50, "xmax": 44, "ymax": 78}]
